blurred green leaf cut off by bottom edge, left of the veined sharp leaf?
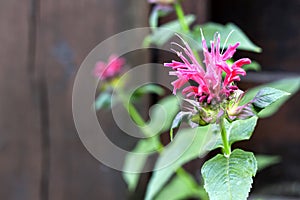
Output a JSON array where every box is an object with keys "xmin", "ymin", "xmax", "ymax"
[{"xmin": 155, "ymin": 172, "xmax": 208, "ymax": 200}]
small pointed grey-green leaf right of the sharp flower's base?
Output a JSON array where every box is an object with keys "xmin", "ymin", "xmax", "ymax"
[{"xmin": 252, "ymin": 87, "xmax": 290, "ymax": 111}]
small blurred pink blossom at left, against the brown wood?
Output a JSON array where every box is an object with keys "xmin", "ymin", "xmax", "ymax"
[{"xmin": 94, "ymin": 55, "xmax": 125, "ymax": 80}]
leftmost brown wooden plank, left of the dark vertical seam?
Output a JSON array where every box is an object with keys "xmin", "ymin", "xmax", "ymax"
[{"xmin": 0, "ymin": 0, "xmax": 41, "ymax": 200}]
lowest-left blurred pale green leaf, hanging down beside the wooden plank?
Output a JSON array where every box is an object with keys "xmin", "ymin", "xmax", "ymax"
[{"xmin": 122, "ymin": 137, "xmax": 161, "ymax": 192}]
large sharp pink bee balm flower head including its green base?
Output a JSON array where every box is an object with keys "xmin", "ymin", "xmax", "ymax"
[{"xmin": 164, "ymin": 30, "xmax": 251, "ymax": 124}]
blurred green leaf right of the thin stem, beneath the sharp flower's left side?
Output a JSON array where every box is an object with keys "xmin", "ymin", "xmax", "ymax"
[{"xmin": 143, "ymin": 95, "xmax": 179, "ymax": 136}]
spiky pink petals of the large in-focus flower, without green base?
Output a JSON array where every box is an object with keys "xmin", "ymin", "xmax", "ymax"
[{"xmin": 164, "ymin": 31, "xmax": 251, "ymax": 103}]
